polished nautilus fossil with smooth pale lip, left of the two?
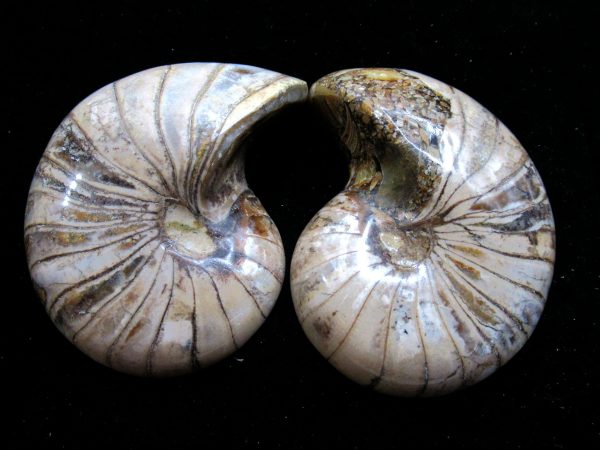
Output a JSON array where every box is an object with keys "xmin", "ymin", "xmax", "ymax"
[{"xmin": 25, "ymin": 63, "xmax": 307, "ymax": 376}]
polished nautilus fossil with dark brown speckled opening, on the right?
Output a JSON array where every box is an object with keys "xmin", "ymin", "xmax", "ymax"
[{"xmin": 291, "ymin": 69, "xmax": 555, "ymax": 396}]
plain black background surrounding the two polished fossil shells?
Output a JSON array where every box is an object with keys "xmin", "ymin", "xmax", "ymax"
[{"xmin": 5, "ymin": 1, "xmax": 600, "ymax": 449}]
